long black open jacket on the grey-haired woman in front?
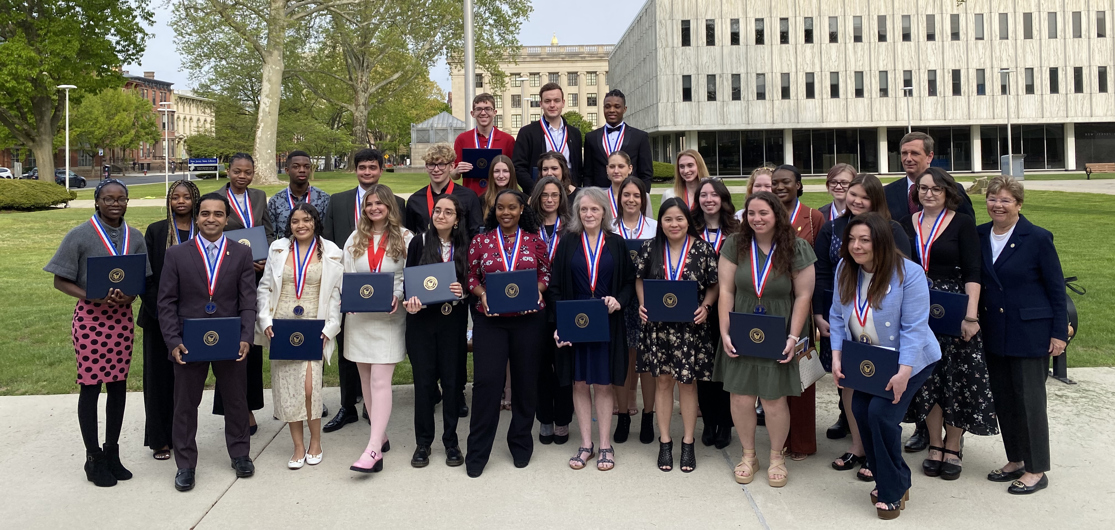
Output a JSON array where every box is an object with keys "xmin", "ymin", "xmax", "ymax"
[{"xmin": 546, "ymin": 232, "xmax": 637, "ymax": 386}]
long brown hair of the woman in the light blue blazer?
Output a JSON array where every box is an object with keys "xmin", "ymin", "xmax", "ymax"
[{"xmin": 836, "ymin": 212, "xmax": 905, "ymax": 309}]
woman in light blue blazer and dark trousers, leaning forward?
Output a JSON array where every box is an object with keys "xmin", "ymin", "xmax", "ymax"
[{"xmin": 828, "ymin": 212, "xmax": 941, "ymax": 519}]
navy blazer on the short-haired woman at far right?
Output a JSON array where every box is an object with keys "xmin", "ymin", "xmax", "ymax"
[{"xmin": 976, "ymin": 215, "xmax": 1068, "ymax": 357}]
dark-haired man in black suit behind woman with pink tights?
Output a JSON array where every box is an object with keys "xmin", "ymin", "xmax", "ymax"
[{"xmin": 321, "ymin": 150, "xmax": 406, "ymax": 433}]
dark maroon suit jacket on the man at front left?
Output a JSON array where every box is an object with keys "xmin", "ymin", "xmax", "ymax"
[{"xmin": 158, "ymin": 240, "xmax": 255, "ymax": 350}]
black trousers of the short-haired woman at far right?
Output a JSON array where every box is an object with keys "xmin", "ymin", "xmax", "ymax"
[{"xmin": 986, "ymin": 355, "xmax": 1049, "ymax": 473}]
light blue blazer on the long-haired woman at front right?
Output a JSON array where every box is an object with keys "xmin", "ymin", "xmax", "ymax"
[{"xmin": 828, "ymin": 259, "xmax": 941, "ymax": 376}]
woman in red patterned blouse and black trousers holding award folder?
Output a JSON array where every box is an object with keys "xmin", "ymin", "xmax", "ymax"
[{"xmin": 465, "ymin": 190, "xmax": 550, "ymax": 479}]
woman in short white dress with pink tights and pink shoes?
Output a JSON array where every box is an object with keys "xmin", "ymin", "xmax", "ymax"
[{"xmin": 343, "ymin": 184, "xmax": 414, "ymax": 473}]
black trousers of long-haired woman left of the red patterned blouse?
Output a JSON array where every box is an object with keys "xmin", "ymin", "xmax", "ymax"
[{"xmin": 406, "ymin": 303, "xmax": 468, "ymax": 447}]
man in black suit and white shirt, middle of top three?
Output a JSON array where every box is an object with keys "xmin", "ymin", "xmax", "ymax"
[{"xmin": 511, "ymin": 83, "xmax": 582, "ymax": 195}]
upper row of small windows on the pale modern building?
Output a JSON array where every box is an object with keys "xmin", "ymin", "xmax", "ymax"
[{"xmin": 677, "ymin": 11, "xmax": 1107, "ymax": 47}]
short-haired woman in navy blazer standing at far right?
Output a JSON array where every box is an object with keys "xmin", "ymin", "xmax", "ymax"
[{"xmin": 977, "ymin": 176, "xmax": 1068, "ymax": 494}]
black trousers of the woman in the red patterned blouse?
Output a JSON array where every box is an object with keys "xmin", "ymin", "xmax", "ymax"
[{"xmin": 465, "ymin": 312, "xmax": 544, "ymax": 471}]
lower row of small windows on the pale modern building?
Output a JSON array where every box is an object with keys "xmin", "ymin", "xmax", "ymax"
[{"xmin": 681, "ymin": 66, "xmax": 1107, "ymax": 102}]
